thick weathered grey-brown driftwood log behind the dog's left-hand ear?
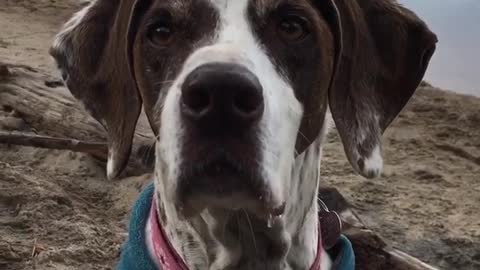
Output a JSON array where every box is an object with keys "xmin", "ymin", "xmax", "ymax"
[{"xmin": 0, "ymin": 63, "xmax": 153, "ymax": 142}]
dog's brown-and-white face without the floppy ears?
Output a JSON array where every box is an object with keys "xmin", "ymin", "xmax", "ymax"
[{"xmin": 133, "ymin": 0, "xmax": 335, "ymax": 217}]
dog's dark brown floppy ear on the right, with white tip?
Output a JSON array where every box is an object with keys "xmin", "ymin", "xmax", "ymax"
[{"xmin": 318, "ymin": 0, "xmax": 437, "ymax": 178}]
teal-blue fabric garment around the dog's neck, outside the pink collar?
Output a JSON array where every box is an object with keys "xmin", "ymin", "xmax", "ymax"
[{"xmin": 117, "ymin": 184, "xmax": 355, "ymax": 270}]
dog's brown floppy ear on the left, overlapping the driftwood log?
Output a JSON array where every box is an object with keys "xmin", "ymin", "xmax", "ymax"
[{"xmin": 50, "ymin": 0, "xmax": 148, "ymax": 179}]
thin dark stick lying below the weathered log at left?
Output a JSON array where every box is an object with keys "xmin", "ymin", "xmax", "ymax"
[{"xmin": 0, "ymin": 131, "xmax": 108, "ymax": 160}]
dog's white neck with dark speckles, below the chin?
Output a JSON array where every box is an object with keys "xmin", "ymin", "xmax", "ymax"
[{"xmin": 156, "ymin": 139, "xmax": 323, "ymax": 270}]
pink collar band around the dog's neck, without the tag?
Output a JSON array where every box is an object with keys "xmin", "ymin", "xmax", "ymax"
[{"xmin": 149, "ymin": 200, "xmax": 323, "ymax": 270}]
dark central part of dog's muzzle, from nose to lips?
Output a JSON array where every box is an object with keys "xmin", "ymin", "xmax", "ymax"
[{"xmin": 178, "ymin": 63, "xmax": 282, "ymax": 215}]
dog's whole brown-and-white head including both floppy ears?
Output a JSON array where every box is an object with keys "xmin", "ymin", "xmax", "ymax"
[{"xmin": 51, "ymin": 0, "xmax": 436, "ymax": 218}]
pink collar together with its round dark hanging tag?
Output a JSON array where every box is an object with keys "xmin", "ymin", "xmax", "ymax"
[{"xmin": 149, "ymin": 197, "xmax": 341, "ymax": 270}]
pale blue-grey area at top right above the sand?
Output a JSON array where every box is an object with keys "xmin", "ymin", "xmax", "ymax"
[{"xmin": 399, "ymin": 0, "xmax": 480, "ymax": 97}]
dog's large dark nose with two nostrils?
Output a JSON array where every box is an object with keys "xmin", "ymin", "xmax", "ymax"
[{"xmin": 181, "ymin": 63, "xmax": 264, "ymax": 125}]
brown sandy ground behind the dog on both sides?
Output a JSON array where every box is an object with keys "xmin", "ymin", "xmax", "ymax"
[{"xmin": 0, "ymin": 0, "xmax": 480, "ymax": 270}]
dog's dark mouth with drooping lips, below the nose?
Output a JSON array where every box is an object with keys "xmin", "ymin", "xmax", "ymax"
[{"xmin": 178, "ymin": 155, "xmax": 285, "ymax": 223}]
